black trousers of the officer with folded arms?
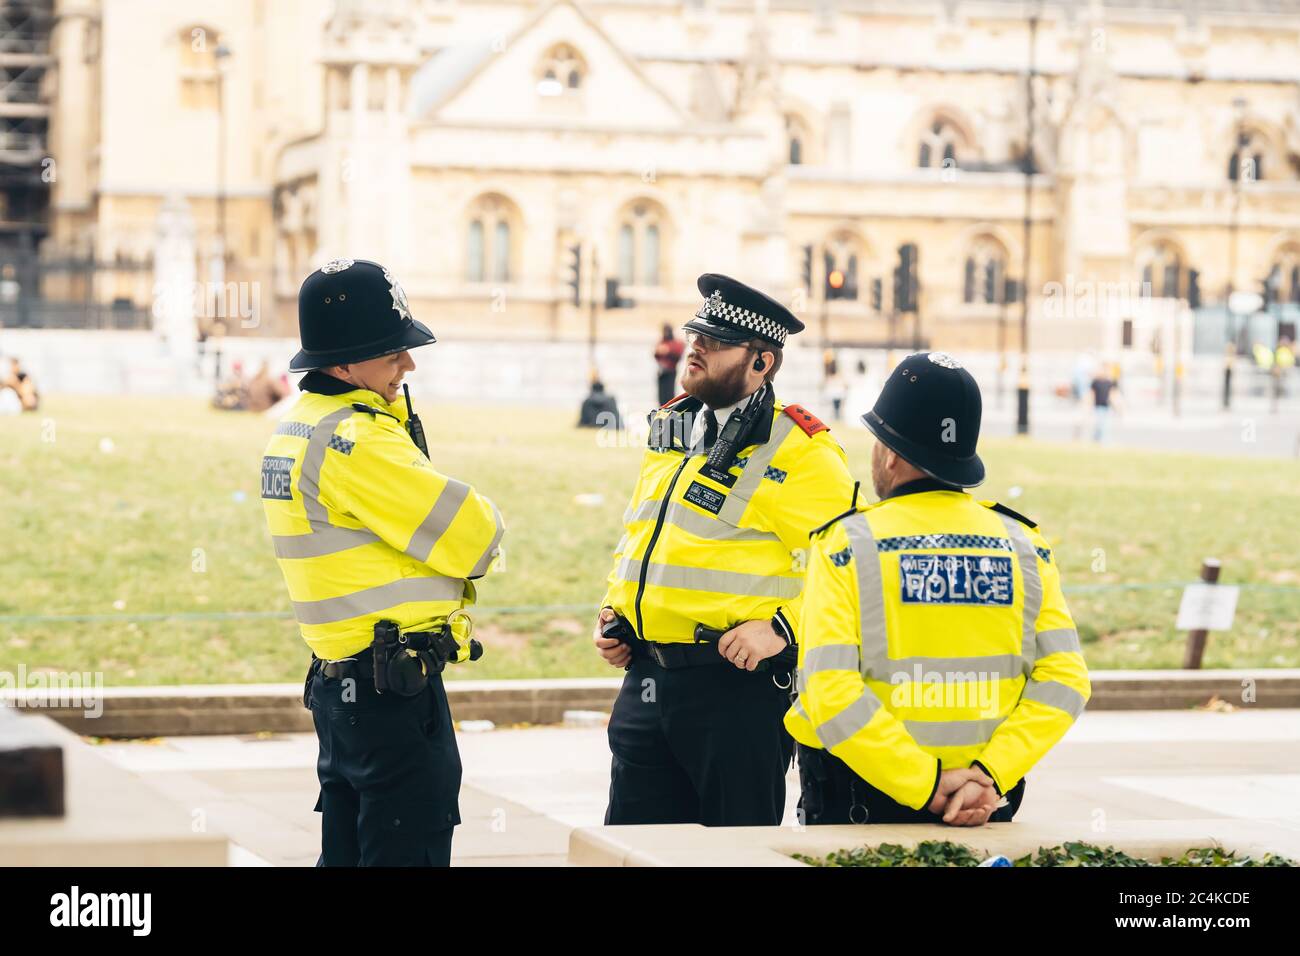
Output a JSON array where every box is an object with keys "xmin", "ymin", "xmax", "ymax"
[{"xmin": 311, "ymin": 660, "xmax": 460, "ymax": 866}]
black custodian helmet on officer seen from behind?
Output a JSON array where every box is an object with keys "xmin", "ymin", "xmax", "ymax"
[{"xmin": 862, "ymin": 352, "xmax": 984, "ymax": 488}]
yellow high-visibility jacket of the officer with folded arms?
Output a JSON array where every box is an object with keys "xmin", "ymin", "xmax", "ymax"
[{"xmin": 261, "ymin": 379, "xmax": 504, "ymax": 661}]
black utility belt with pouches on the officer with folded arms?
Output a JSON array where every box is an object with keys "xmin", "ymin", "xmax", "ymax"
[{"xmin": 303, "ymin": 610, "xmax": 484, "ymax": 706}]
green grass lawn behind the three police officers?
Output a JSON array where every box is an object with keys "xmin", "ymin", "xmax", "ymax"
[{"xmin": 0, "ymin": 397, "xmax": 1300, "ymax": 684}]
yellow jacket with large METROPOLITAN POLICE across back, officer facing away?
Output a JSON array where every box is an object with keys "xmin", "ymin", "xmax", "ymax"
[{"xmin": 785, "ymin": 481, "xmax": 1091, "ymax": 809}]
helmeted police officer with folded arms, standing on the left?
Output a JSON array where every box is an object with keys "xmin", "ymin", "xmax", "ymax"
[{"xmin": 261, "ymin": 259, "xmax": 503, "ymax": 866}]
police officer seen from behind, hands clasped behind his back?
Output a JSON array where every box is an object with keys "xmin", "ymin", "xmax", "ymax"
[{"xmin": 785, "ymin": 352, "xmax": 1091, "ymax": 826}]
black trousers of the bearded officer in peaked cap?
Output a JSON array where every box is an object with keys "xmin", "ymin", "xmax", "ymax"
[{"xmin": 605, "ymin": 657, "xmax": 794, "ymax": 826}]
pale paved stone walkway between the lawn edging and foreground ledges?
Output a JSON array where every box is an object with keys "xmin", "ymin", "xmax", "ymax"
[{"xmin": 98, "ymin": 710, "xmax": 1300, "ymax": 866}]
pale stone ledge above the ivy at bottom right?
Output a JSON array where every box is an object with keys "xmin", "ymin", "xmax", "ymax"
[{"xmin": 568, "ymin": 818, "xmax": 1300, "ymax": 866}]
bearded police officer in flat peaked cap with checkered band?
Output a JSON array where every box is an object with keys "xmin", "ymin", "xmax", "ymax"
[{"xmin": 594, "ymin": 274, "xmax": 853, "ymax": 826}]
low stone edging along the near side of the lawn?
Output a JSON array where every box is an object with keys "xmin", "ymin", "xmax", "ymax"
[{"xmin": 0, "ymin": 669, "xmax": 1300, "ymax": 737}]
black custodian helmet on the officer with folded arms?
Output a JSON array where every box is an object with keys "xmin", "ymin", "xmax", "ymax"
[{"xmin": 289, "ymin": 259, "xmax": 437, "ymax": 372}]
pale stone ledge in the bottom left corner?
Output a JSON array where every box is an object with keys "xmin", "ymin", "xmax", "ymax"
[{"xmin": 0, "ymin": 717, "xmax": 229, "ymax": 868}]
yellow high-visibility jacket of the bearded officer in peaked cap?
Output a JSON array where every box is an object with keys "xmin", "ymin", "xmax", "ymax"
[{"xmin": 603, "ymin": 397, "xmax": 853, "ymax": 644}]
